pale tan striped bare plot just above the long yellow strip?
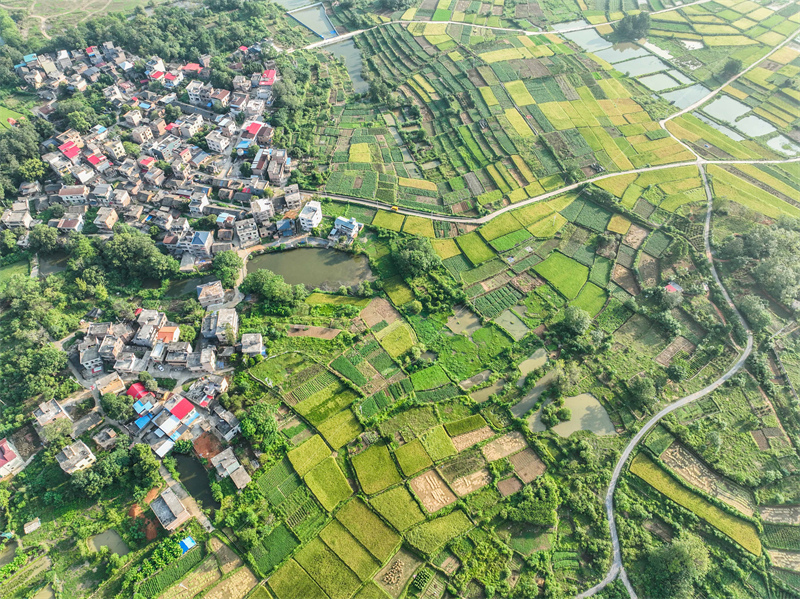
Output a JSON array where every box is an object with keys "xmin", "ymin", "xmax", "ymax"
[{"xmin": 661, "ymin": 442, "xmax": 755, "ymax": 516}]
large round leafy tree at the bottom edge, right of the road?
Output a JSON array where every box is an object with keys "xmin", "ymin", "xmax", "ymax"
[{"xmin": 647, "ymin": 531, "xmax": 711, "ymax": 599}]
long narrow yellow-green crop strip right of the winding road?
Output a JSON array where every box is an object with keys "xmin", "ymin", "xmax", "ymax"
[{"xmin": 631, "ymin": 453, "xmax": 761, "ymax": 555}]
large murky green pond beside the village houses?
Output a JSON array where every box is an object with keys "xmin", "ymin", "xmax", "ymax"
[{"xmin": 247, "ymin": 248, "xmax": 374, "ymax": 291}]
